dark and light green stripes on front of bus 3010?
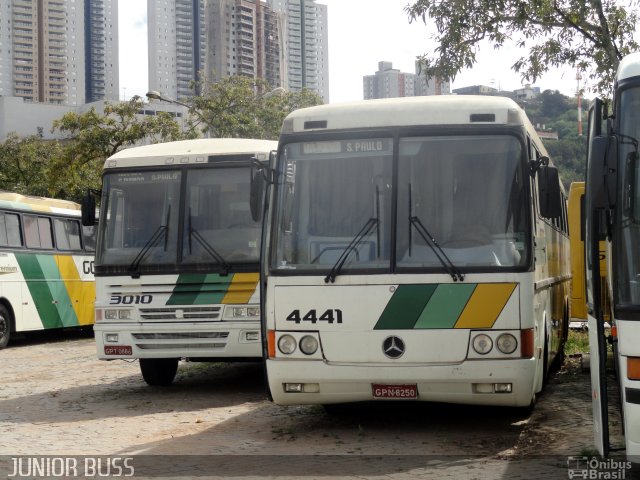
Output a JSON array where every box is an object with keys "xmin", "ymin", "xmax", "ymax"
[{"xmin": 167, "ymin": 273, "xmax": 233, "ymax": 305}]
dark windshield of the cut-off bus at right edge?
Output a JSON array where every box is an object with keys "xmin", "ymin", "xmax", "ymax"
[{"xmin": 613, "ymin": 87, "xmax": 640, "ymax": 307}]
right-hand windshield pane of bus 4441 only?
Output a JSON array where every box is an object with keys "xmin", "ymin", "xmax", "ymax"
[{"xmin": 396, "ymin": 135, "xmax": 527, "ymax": 268}]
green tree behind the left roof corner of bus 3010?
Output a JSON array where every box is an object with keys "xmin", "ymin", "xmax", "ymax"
[{"xmin": 50, "ymin": 97, "xmax": 186, "ymax": 199}]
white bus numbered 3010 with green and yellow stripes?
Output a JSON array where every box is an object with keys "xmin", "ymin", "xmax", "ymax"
[{"xmin": 86, "ymin": 139, "xmax": 277, "ymax": 386}]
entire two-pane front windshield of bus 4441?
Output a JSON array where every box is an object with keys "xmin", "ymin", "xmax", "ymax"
[{"xmin": 272, "ymin": 135, "xmax": 530, "ymax": 275}]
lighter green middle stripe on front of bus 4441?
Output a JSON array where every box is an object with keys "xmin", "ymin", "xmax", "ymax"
[{"xmin": 414, "ymin": 283, "xmax": 476, "ymax": 328}]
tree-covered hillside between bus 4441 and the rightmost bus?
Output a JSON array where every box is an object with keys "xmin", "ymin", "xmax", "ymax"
[{"xmin": 520, "ymin": 90, "xmax": 590, "ymax": 189}]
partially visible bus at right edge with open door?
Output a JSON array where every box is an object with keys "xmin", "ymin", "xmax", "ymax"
[{"xmin": 585, "ymin": 53, "xmax": 640, "ymax": 462}]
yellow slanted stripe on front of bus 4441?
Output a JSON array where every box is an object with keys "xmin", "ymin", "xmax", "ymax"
[{"xmin": 454, "ymin": 283, "xmax": 516, "ymax": 328}]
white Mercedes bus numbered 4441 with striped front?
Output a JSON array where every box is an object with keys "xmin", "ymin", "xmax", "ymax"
[{"xmin": 253, "ymin": 96, "xmax": 571, "ymax": 408}]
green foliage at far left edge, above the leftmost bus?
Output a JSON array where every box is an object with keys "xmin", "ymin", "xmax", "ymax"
[{"xmin": 0, "ymin": 133, "xmax": 61, "ymax": 197}]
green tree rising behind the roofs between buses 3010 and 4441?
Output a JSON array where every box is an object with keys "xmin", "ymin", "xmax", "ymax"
[{"xmin": 189, "ymin": 76, "xmax": 322, "ymax": 139}]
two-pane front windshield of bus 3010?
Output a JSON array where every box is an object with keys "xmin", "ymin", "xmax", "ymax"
[{"xmin": 96, "ymin": 166, "xmax": 261, "ymax": 271}]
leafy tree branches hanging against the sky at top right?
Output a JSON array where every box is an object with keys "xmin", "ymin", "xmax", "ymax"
[{"xmin": 405, "ymin": 0, "xmax": 638, "ymax": 95}]
